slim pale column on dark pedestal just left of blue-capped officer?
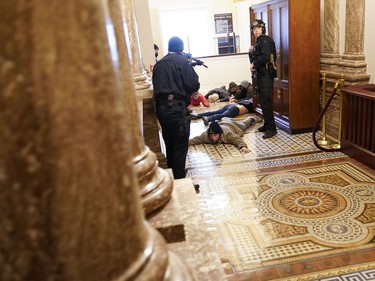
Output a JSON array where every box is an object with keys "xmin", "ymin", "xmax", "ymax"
[{"xmin": 120, "ymin": 0, "xmax": 167, "ymax": 168}]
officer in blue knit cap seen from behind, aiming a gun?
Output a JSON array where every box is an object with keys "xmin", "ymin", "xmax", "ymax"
[{"xmin": 152, "ymin": 36, "xmax": 200, "ymax": 179}]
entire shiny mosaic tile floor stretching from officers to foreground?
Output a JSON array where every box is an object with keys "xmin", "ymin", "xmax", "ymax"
[{"xmin": 187, "ymin": 104, "xmax": 375, "ymax": 280}]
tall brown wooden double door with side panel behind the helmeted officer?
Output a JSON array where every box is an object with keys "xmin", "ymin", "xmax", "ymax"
[{"xmin": 250, "ymin": 0, "xmax": 320, "ymax": 134}]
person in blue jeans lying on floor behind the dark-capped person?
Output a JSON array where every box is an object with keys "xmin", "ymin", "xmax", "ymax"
[{"xmin": 191, "ymin": 99, "xmax": 254, "ymax": 126}]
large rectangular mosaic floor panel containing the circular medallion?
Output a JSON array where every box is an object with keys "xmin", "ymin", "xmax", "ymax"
[{"xmin": 191, "ymin": 162, "xmax": 375, "ymax": 272}]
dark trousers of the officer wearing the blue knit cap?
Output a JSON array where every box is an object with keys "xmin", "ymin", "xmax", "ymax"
[{"xmin": 156, "ymin": 103, "xmax": 190, "ymax": 179}]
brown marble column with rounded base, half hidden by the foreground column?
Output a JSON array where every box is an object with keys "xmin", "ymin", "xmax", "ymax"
[{"xmin": 109, "ymin": 0, "xmax": 173, "ymax": 215}]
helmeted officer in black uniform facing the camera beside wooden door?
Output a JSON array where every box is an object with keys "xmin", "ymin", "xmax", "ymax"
[{"xmin": 249, "ymin": 19, "xmax": 277, "ymax": 139}]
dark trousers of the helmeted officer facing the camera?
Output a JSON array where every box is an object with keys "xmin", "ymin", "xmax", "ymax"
[{"xmin": 257, "ymin": 73, "xmax": 276, "ymax": 131}]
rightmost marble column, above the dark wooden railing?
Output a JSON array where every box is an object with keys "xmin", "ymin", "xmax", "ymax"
[{"xmin": 342, "ymin": 0, "xmax": 370, "ymax": 84}]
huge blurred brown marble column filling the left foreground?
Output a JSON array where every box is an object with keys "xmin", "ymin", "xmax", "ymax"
[{"xmin": 0, "ymin": 0, "xmax": 191, "ymax": 281}]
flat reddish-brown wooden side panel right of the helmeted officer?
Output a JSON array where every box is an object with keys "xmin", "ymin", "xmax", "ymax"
[{"xmin": 288, "ymin": 0, "xmax": 320, "ymax": 130}]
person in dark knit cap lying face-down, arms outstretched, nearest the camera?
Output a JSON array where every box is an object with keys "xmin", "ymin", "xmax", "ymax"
[{"xmin": 189, "ymin": 116, "xmax": 259, "ymax": 153}]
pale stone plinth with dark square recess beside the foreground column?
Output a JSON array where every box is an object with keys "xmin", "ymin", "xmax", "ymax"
[{"xmin": 148, "ymin": 178, "xmax": 225, "ymax": 280}]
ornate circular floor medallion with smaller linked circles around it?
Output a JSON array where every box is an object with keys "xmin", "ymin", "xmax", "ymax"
[{"xmin": 259, "ymin": 173, "xmax": 374, "ymax": 247}]
